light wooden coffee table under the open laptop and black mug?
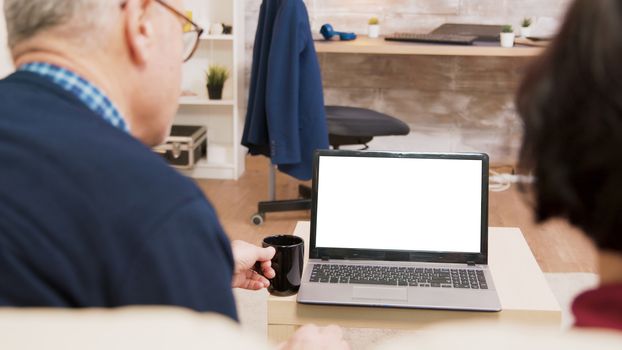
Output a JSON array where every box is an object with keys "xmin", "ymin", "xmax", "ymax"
[{"xmin": 268, "ymin": 221, "xmax": 561, "ymax": 342}]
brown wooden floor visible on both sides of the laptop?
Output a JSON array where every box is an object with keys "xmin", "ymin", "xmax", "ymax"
[{"xmin": 198, "ymin": 157, "xmax": 596, "ymax": 272}]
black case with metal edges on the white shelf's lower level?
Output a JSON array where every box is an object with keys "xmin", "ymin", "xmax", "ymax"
[{"xmin": 154, "ymin": 125, "xmax": 207, "ymax": 169}]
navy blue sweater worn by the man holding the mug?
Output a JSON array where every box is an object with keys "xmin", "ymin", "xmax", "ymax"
[{"xmin": 0, "ymin": 72, "xmax": 237, "ymax": 319}]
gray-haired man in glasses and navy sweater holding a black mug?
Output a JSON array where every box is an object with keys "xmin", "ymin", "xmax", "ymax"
[{"xmin": 0, "ymin": 0, "xmax": 348, "ymax": 344}]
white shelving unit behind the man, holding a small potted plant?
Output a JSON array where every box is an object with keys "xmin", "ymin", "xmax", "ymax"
[{"xmin": 175, "ymin": 0, "xmax": 246, "ymax": 179}]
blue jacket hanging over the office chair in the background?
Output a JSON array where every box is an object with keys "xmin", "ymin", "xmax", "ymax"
[{"xmin": 242, "ymin": 0, "xmax": 328, "ymax": 180}]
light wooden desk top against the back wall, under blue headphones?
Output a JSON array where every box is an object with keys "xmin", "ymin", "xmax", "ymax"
[{"xmin": 315, "ymin": 35, "xmax": 543, "ymax": 57}]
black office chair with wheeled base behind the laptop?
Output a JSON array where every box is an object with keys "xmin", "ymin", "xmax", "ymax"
[{"xmin": 251, "ymin": 106, "xmax": 410, "ymax": 225}]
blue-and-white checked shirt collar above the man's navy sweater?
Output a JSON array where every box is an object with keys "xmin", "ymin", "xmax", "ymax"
[{"xmin": 18, "ymin": 62, "xmax": 129, "ymax": 132}]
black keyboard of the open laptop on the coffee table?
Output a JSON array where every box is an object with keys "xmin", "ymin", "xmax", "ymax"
[{"xmin": 309, "ymin": 264, "xmax": 488, "ymax": 289}]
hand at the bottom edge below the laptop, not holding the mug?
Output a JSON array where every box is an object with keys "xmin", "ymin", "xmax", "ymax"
[{"xmin": 278, "ymin": 325, "xmax": 350, "ymax": 350}]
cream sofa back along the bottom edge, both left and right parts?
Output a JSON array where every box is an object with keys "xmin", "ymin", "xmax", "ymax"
[{"xmin": 0, "ymin": 307, "xmax": 622, "ymax": 350}]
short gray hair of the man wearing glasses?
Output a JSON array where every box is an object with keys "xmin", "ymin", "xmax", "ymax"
[{"xmin": 4, "ymin": 0, "xmax": 120, "ymax": 48}]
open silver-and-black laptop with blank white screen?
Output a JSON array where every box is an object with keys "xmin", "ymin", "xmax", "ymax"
[{"xmin": 297, "ymin": 150, "xmax": 501, "ymax": 311}]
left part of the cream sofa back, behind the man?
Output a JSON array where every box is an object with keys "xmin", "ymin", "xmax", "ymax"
[{"xmin": 0, "ymin": 307, "xmax": 270, "ymax": 350}]
